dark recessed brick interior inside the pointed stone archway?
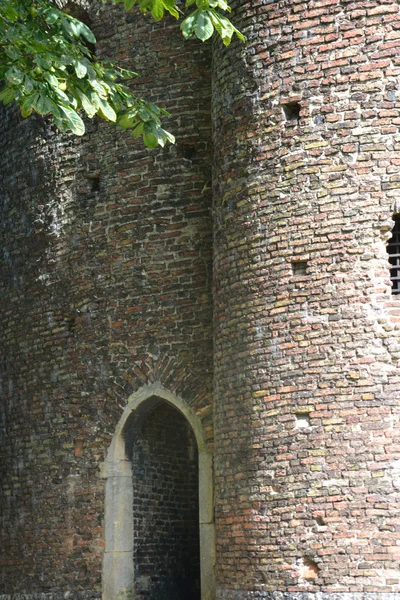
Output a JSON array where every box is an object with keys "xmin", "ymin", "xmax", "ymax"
[{"xmin": 132, "ymin": 401, "xmax": 200, "ymax": 600}]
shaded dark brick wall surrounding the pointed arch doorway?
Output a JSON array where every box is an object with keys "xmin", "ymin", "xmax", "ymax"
[{"xmin": 0, "ymin": 2, "xmax": 212, "ymax": 597}]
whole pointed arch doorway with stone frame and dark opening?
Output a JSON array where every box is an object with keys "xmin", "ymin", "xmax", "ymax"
[{"xmin": 103, "ymin": 384, "xmax": 215, "ymax": 600}]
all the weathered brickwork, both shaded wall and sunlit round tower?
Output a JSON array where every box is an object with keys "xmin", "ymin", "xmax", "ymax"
[{"xmin": 0, "ymin": 0, "xmax": 400, "ymax": 600}]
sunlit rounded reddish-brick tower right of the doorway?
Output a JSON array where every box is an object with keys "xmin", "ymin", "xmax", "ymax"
[{"xmin": 213, "ymin": 0, "xmax": 400, "ymax": 600}]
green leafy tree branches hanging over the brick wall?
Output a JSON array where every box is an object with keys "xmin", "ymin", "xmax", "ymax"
[{"xmin": 0, "ymin": 0, "xmax": 244, "ymax": 148}]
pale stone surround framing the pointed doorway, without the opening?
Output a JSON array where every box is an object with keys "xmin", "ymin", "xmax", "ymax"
[{"xmin": 102, "ymin": 382, "xmax": 215, "ymax": 600}]
